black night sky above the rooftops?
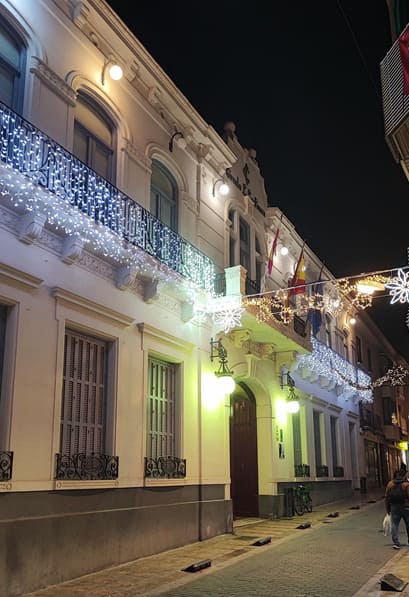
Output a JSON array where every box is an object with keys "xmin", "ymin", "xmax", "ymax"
[{"xmin": 108, "ymin": 0, "xmax": 409, "ymax": 358}]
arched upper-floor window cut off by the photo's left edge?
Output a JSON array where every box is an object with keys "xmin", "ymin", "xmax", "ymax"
[{"xmin": 0, "ymin": 18, "xmax": 26, "ymax": 112}]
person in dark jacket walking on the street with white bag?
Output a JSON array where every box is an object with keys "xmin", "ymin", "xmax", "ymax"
[{"xmin": 385, "ymin": 469, "xmax": 409, "ymax": 549}]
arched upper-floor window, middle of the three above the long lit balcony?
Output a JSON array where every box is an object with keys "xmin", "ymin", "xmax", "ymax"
[{"xmin": 73, "ymin": 93, "xmax": 115, "ymax": 183}]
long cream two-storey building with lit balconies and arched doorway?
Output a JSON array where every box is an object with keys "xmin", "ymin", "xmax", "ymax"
[{"xmin": 0, "ymin": 0, "xmax": 407, "ymax": 597}]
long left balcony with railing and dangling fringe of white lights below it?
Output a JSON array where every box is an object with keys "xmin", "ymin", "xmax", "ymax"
[{"xmin": 0, "ymin": 103, "xmax": 214, "ymax": 293}]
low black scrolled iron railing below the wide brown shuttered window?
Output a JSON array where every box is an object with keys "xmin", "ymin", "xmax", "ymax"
[{"xmin": 55, "ymin": 454, "xmax": 119, "ymax": 481}]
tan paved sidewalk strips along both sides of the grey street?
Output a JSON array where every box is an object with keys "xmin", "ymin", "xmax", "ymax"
[{"xmin": 25, "ymin": 491, "xmax": 392, "ymax": 597}]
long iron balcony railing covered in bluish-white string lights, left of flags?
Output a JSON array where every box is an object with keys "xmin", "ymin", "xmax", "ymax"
[{"xmin": 0, "ymin": 103, "xmax": 214, "ymax": 292}]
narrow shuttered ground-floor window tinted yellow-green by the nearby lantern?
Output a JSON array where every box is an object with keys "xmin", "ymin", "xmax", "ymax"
[{"xmin": 147, "ymin": 357, "xmax": 180, "ymax": 458}]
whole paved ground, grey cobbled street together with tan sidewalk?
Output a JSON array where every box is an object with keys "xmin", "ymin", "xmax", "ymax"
[{"xmin": 23, "ymin": 496, "xmax": 409, "ymax": 597}]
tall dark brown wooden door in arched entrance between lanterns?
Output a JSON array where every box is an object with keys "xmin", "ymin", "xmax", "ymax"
[{"xmin": 230, "ymin": 384, "xmax": 258, "ymax": 518}]
